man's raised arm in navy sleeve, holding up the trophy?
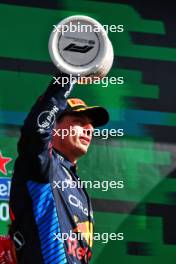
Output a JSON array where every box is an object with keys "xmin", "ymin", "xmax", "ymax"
[{"xmin": 18, "ymin": 73, "xmax": 73, "ymax": 168}]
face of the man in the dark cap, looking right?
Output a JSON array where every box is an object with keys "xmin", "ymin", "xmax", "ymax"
[{"xmin": 53, "ymin": 114, "xmax": 93, "ymax": 159}]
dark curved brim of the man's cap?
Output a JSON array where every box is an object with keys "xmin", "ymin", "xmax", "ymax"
[{"xmin": 71, "ymin": 106, "xmax": 109, "ymax": 127}]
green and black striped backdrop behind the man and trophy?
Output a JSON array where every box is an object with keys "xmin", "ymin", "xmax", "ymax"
[{"xmin": 0, "ymin": 0, "xmax": 176, "ymax": 264}]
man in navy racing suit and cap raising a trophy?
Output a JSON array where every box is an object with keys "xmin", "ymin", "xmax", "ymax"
[{"xmin": 9, "ymin": 74, "xmax": 109, "ymax": 264}]
